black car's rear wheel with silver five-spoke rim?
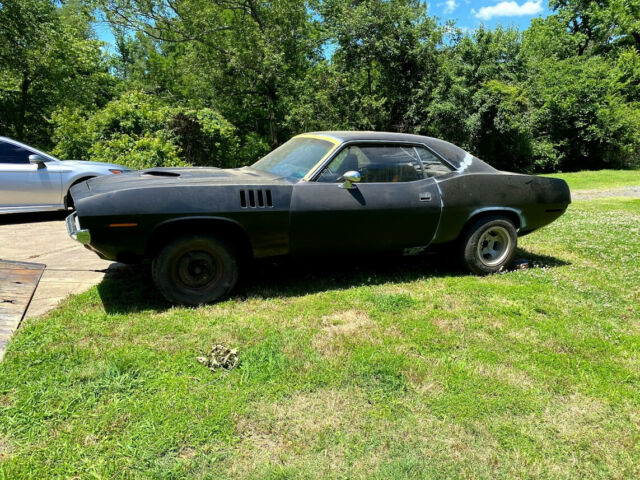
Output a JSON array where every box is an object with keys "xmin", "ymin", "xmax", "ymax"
[{"xmin": 460, "ymin": 215, "xmax": 518, "ymax": 275}]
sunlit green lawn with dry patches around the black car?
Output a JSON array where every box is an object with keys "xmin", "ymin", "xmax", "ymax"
[{"xmin": 0, "ymin": 172, "xmax": 640, "ymax": 479}]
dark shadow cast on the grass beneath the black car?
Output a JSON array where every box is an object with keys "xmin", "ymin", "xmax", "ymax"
[{"xmin": 98, "ymin": 249, "xmax": 568, "ymax": 313}]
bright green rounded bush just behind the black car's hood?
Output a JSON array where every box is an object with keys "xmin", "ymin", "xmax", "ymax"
[{"xmin": 52, "ymin": 91, "xmax": 239, "ymax": 169}]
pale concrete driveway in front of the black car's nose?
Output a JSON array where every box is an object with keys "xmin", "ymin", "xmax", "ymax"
[{"xmin": 0, "ymin": 212, "xmax": 115, "ymax": 318}]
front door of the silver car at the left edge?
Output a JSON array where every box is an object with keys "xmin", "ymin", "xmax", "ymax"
[{"xmin": 0, "ymin": 140, "xmax": 62, "ymax": 209}]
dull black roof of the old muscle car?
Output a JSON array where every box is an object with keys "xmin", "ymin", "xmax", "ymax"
[{"xmin": 302, "ymin": 130, "xmax": 484, "ymax": 168}]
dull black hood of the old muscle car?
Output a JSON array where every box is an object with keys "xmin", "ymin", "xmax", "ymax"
[{"xmin": 82, "ymin": 167, "xmax": 290, "ymax": 194}]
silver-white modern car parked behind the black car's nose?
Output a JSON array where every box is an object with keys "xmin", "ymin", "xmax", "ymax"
[{"xmin": 0, "ymin": 137, "xmax": 130, "ymax": 214}]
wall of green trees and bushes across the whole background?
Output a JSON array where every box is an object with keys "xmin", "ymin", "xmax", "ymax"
[{"xmin": 0, "ymin": 0, "xmax": 640, "ymax": 172}]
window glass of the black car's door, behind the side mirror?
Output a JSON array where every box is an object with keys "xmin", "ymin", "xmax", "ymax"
[{"xmin": 318, "ymin": 145, "xmax": 424, "ymax": 183}]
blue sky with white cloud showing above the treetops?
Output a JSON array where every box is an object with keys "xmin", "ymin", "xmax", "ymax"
[{"xmin": 94, "ymin": 0, "xmax": 551, "ymax": 48}]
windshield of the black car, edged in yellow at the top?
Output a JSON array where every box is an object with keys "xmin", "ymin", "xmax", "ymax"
[{"xmin": 251, "ymin": 137, "xmax": 333, "ymax": 180}]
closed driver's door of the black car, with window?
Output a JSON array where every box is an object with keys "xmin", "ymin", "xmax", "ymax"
[{"xmin": 290, "ymin": 144, "xmax": 441, "ymax": 255}]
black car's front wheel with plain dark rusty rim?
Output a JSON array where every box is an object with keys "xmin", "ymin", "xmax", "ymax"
[{"xmin": 151, "ymin": 235, "xmax": 239, "ymax": 305}]
